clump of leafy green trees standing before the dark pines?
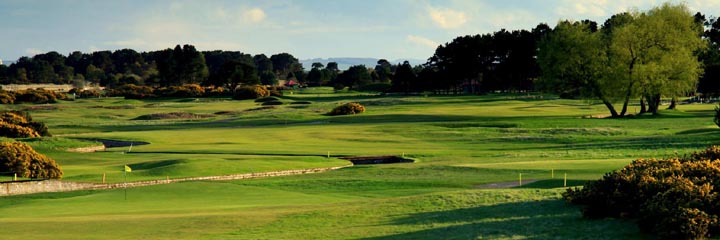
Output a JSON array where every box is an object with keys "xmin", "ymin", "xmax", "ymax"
[{"xmin": 538, "ymin": 3, "xmax": 705, "ymax": 117}]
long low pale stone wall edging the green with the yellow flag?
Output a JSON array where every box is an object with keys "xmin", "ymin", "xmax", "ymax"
[{"xmin": 0, "ymin": 165, "xmax": 351, "ymax": 196}]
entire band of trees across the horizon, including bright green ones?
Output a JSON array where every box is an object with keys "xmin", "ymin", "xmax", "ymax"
[{"xmin": 0, "ymin": 4, "xmax": 720, "ymax": 105}]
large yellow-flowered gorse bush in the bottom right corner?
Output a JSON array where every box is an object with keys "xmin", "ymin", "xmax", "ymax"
[{"xmin": 563, "ymin": 146, "xmax": 720, "ymax": 239}]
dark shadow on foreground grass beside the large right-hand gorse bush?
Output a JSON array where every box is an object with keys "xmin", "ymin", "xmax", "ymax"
[{"xmin": 364, "ymin": 200, "xmax": 650, "ymax": 240}]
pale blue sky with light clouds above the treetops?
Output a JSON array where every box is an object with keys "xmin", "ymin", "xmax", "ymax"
[{"xmin": 0, "ymin": 0, "xmax": 720, "ymax": 61}]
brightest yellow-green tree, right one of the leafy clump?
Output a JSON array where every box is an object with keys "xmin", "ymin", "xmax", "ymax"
[{"xmin": 610, "ymin": 3, "xmax": 706, "ymax": 114}]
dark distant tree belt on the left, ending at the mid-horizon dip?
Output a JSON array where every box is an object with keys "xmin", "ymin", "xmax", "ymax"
[{"xmin": 0, "ymin": 44, "xmax": 303, "ymax": 88}]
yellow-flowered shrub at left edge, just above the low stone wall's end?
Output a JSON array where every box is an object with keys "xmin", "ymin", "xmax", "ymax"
[{"xmin": 0, "ymin": 142, "xmax": 63, "ymax": 179}]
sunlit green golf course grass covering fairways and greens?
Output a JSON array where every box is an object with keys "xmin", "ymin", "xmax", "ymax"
[{"xmin": 0, "ymin": 92, "xmax": 720, "ymax": 239}]
